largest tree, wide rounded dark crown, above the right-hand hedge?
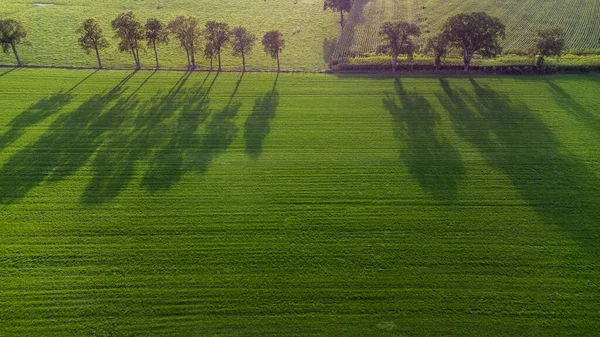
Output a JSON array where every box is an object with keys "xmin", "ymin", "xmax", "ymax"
[{"xmin": 443, "ymin": 12, "xmax": 506, "ymax": 73}]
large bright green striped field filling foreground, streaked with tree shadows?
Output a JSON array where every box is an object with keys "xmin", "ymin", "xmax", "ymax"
[{"xmin": 0, "ymin": 69, "xmax": 600, "ymax": 336}]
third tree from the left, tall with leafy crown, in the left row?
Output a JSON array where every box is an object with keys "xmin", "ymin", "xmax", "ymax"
[{"xmin": 111, "ymin": 11, "xmax": 144, "ymax": 69}]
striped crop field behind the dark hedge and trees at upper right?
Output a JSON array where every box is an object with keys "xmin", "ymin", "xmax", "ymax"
[{"xmin": 333, "ymin": 0, "xmax": 600, "ymax": 60}]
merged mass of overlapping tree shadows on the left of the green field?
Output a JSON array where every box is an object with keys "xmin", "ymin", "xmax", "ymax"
[{"xmin": 0, "ymin": 72, "xmax": 251, "ymax": 205}]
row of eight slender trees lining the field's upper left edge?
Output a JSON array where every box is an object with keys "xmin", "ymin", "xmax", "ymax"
[{"xmin": 0, "ymin": 11, "xmax": 285, "ymax": 71}]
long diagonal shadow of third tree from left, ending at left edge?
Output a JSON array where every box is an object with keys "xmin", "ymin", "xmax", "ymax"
[{"xmin": 0, "ymin": 73, "xmax": 133, "ymax": 204}]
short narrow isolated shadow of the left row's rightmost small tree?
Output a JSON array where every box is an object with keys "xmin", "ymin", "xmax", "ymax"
[{"xmin": 244, "ymin": 75, "xmax": 279, "ymax": 159}]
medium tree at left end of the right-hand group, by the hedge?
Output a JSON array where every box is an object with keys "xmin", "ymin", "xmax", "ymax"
[{"xmin": 377, "ymin": 22, "xmax": 421, "ymax": 71}]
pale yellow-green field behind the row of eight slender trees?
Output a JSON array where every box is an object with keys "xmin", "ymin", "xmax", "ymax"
[{"xmin": 0, "ymin": 0, "xmax": 340, "ymax": 71}]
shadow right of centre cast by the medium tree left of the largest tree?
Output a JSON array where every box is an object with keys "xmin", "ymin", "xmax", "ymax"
[{"xmin": 383, "ymin": 78, "xmax": 465, "ymax": 200}]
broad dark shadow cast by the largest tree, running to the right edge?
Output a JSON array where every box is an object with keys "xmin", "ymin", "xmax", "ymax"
[{"xmin": 438, "ymin": 80, "xmax": 600, "ymax": 254}]
